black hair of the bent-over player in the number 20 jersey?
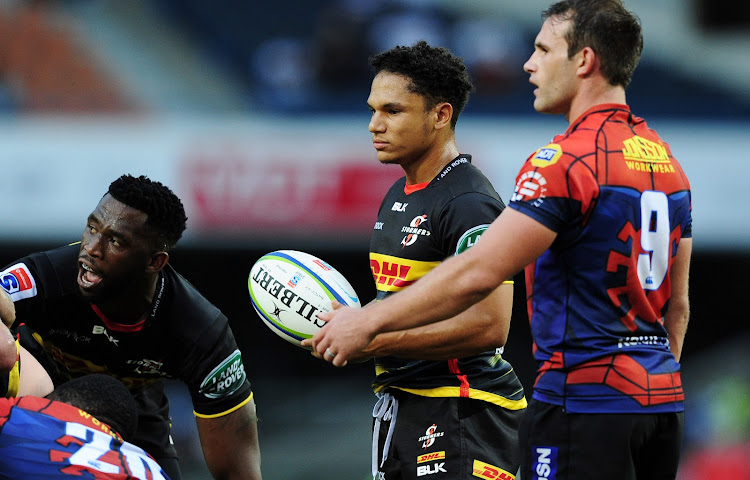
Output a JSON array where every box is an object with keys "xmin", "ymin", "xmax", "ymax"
[{"xmin": 47, "ymin": 373, "xmax": 138, "ymax": 440}]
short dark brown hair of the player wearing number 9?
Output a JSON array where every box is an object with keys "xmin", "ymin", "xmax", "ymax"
[{"xmin": 542, "ymin": 0, "xmax": 643, "ymax": 87}]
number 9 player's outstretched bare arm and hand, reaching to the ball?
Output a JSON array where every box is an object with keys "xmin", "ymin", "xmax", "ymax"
[{"xmin": 313, "ymin": 208, "xmax": 557, "ymax": 366}]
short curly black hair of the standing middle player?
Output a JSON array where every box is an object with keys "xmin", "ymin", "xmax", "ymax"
[{"xmin": 370, "ymin": 40, "xmax": 474, "ymax": 129}]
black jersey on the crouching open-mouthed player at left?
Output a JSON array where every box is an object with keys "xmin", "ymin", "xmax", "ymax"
[{"xmin": 0, "ymin": 244, "xmax": 252, "ymax": 458}]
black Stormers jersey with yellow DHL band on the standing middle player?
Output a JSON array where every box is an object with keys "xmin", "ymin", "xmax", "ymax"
[{"xmin": 370, "ymin": 155, "xmax": 526, "ymax": 410}]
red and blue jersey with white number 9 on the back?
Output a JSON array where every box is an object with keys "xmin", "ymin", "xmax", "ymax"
[{"xmin": 509, "ymin": 104, "xmax": 692, "ymax": 413}]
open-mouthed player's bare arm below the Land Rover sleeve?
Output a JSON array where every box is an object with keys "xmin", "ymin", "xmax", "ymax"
[{"xmin": 196, "ymin": 398, "xmax": 261, "ymax": 480}]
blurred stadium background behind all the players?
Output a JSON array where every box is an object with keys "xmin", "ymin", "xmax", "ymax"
[{"xmin": 0, "ymin": 0, "xmax": 750, "ymax": 480}]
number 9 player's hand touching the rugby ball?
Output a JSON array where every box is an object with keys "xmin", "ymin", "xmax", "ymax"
[{"xmin": 302, "ymin": 305, "xmax": 375, "ymax": 367}]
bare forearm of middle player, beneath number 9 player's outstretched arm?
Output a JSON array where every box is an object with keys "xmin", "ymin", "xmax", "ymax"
[{"xmin": 363, "ymin": 283, "xmax": 513, "ymax": 360}]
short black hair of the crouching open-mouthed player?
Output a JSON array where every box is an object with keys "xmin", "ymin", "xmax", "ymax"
[{"xmin": 107, "ymin": 174, "xmax": 187, "ymax": 251}]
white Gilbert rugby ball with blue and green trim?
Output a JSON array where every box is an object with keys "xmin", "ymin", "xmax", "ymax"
[{"xmin": 247, "ymin": 250, "xmax": 361, "ymax": 348}]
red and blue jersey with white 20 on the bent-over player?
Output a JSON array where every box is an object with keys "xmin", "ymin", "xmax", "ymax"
[{"xmin": 0, "ymin": 396, "xmax": 168, "ymax": 480}]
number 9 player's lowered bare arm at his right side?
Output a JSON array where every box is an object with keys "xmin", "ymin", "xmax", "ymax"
[{"xmin": 664, "ymin": 238, "xmax": 693, "ymax": 362}]
